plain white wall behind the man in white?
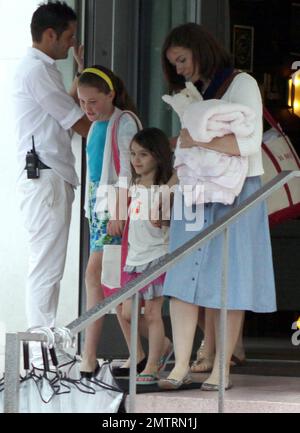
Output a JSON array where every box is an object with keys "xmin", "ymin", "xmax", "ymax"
[{"xmin": 0, "ymin": 0, "xmax": 81, "ymax": 353}]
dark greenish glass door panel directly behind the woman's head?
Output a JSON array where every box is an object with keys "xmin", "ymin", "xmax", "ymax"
[{"xmin": 138, "ymin": 0, "xmax": 201, "ymax": 136}]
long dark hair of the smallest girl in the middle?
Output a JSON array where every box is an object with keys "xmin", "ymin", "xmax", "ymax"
[{"xmin": 131, "ymin": 128, "xmax": 173, "ymax": 185}]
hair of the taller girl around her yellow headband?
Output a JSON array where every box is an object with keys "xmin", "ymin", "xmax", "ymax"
[{"xmin": 78, "ymin": 65, "xmax": 137, "ymax": 114}]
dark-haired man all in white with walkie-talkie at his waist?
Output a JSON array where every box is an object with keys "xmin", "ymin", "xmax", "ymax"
[{"xmin": 13, "ymin": 1, "xmax": 90, "ymax": 334}]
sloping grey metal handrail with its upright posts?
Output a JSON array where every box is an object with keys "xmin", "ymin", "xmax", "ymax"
[{"xmin": 4, "ymin": 171, "xmax": 300, "ymax": 413}]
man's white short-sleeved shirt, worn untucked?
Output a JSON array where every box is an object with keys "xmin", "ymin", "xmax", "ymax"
[{"xmin": 13, "ymin": 48, "xmax": 84, "ymax": 186}]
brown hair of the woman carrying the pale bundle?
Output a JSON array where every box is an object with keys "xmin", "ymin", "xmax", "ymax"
[{"xmin": 162, "ymin": 23, "xmax": 233, "ymax": 91}]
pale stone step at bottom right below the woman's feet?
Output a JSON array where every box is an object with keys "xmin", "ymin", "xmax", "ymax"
[{"xmin": 132, "ymin": 374, "xmax": 300, "ymax": 413}]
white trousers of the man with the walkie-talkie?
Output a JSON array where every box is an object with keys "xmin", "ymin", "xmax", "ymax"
[{"xmin": 18, "ymin": 170, "xmax": 74, "ymax": 327}]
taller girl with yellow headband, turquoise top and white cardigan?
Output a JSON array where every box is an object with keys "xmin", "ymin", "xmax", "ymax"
[{"xmin": 77, "ymin": 65, "xmax": 145, "ymax": 377}]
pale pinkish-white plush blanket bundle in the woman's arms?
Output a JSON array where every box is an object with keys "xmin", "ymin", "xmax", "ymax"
[{"xmin": 162, "ymin": 82, "xmax": 256, "ymax": 206}]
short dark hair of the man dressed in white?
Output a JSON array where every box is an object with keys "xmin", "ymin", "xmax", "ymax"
[{"xmin": 31, "ymin": 1, "xmax": 77, "ymax": 42}]
